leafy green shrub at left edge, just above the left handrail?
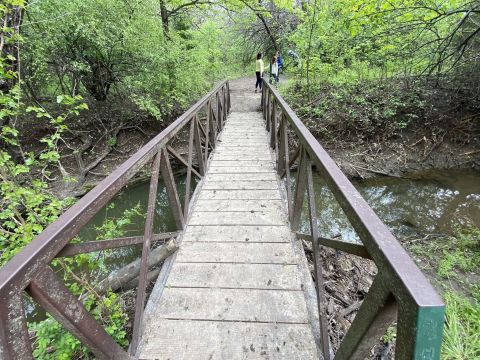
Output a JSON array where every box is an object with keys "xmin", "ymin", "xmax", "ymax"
[{"xmin": 0, "ymin": 95, "xmax": 85, "ymax": 265}]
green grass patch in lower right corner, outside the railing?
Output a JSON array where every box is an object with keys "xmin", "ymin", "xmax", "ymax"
[{"xmin": 407, "ymin": 228, "xmax": 480, "ymax": 360}]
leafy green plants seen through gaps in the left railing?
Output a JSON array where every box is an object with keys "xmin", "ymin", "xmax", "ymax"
[{"xmin": 29, "ymin": 205, "xmax": 144, "ymax": 360}]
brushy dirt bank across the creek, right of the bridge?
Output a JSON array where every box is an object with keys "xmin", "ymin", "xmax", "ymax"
[{"xmin": 282, "ymin": 79, "xmax": 480, "ymax": 179}]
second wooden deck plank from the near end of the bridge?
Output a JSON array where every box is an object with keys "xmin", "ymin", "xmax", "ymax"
[{"xmin": 152, "ymin": 287, "xmax": 308, "ymax": 325}]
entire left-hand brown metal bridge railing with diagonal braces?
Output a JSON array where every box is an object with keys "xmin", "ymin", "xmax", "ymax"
[{"xmin": 0, "ymin": 81, "xmax": 230, "ymax": 360}]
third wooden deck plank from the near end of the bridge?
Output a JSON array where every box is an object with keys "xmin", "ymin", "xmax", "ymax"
[{"xmin": 167, "ymin": 263, "xmax": 302, "ymax": 290}]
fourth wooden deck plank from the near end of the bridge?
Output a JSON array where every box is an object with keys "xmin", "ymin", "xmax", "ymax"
[{"xmin": 177, "ymin": 242, "xmax": 295, "ymax": 264}]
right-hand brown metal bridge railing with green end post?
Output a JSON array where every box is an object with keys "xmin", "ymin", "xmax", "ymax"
[{"xmin": 262, "ymin": 81, "xmax": 445, "ymax": 360}]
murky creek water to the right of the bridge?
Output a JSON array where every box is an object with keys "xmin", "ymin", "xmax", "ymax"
[{"xmin": 302, "ymin": 171, "xmax": 480, "ymax": 240}]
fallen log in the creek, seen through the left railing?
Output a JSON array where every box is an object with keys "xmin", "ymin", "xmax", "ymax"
[{"xmin": 95, "ymin": 239, "xmax": 178, "ymax": 295}]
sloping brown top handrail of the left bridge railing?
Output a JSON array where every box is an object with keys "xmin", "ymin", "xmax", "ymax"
[{"xmin": 0, "ymin": 80, "xmax": 227, "ymax": 294}]
